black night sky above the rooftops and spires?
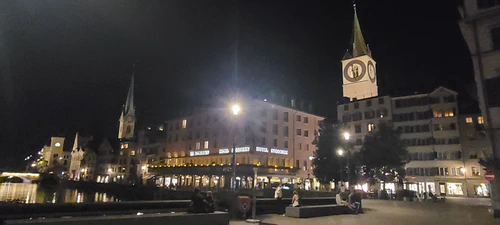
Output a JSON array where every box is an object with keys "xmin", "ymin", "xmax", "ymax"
[{"xmin": 0, "ymin": 0, "xmax": 474, "ymax": 168}]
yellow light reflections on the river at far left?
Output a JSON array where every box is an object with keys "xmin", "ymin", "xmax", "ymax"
[{"xmin": 0, "ymin": 183, "xmax": 119, "ymax": 203}]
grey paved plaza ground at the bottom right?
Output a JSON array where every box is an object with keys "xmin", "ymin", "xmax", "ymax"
[{"xmin": 230, "ymin": 199, "xmax": 500, "ymax": 225}]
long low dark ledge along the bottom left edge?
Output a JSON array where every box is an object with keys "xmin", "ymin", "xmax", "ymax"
[{"xmin": 3, "ymin": 212, "xmax": 229, "ymax": 225}]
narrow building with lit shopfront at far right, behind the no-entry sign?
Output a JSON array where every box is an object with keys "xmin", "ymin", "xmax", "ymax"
[{"xmin": 458, "ymin": 114, "xmax": 491, "ymax": 197}]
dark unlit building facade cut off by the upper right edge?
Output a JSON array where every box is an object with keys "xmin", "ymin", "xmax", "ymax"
[{"xmin": 459, "ymin": 0, "xmax": 500, "ymax": 162}]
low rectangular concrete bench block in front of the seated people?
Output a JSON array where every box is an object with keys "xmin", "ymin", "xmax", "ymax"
[{"xmin": 285, "ymin": 205, "xmax": 349, "ymax": 218}]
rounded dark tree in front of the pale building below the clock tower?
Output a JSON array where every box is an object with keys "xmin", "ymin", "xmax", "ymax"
[{"xmin": 360, "ymin": 123, "xmax": 408, "ymax": 189}]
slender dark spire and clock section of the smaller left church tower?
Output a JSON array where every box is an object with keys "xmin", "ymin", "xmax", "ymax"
[{"xmin": 118, "ymin": 75, "xmax": 135, "ymax": 139}]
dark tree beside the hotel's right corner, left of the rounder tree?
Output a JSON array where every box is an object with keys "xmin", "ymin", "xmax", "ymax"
[{"xmin": 313, "ymin": 120, "xmax": 346, "ymax": 188}]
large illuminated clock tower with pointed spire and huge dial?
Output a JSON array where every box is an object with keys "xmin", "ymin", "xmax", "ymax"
[{"xmin": 342, "ymin": 4, "xmax": 378, "ymax": 101}]
